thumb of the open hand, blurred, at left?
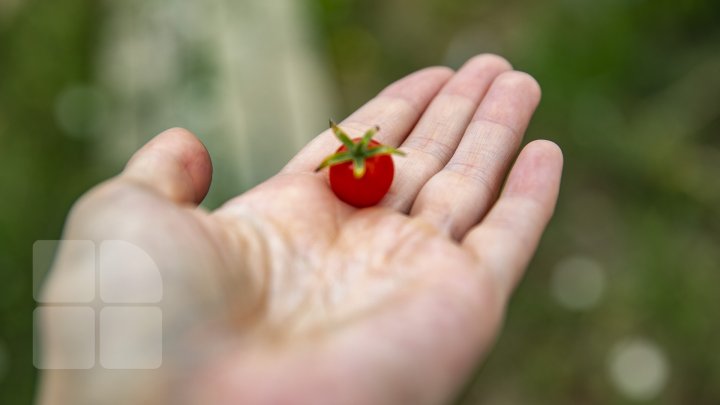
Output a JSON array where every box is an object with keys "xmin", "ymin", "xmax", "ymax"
[{"xmin": 120, "ymin": 128, "xmax": 212, "ymax": 204}]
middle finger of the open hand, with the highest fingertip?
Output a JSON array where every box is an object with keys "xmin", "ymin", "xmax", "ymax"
[{"xmin": 381, "ymin": 54, "xmax": 512, "ymax": 212}]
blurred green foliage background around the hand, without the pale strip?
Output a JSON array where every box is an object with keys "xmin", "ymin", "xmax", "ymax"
[{"xmin": 0, "ymin": 0, "xmax": 720, "ymax": 404}]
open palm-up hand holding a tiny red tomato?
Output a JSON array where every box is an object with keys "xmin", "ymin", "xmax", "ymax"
[{"xmin": 41, "ymin": 55, "xmax": 562, "ymax": 404}]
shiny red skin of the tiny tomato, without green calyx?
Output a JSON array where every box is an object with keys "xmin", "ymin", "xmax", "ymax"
[{"xmin": 329, "ymin": 138, "xmax": 395, "ymax": 208}]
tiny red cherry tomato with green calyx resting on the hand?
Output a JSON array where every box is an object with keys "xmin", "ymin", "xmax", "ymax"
[{"xmin": 316, "ymin": 122, "xmax": 404, "ymax": 208}]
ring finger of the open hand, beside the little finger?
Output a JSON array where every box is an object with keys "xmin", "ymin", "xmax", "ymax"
[{"xmin": 411, "ymin": 71, "xmax": 540, "ymax": 239}]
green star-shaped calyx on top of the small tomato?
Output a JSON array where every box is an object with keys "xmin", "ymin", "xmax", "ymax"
[{"xmin": 315, "ymin": 120, "xmax": 405, "ymax": 179}]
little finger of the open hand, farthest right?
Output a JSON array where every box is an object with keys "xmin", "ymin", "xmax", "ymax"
[{"xmin": 462, "ymin": 141, "xmax": 563, "ymax": 294}]
